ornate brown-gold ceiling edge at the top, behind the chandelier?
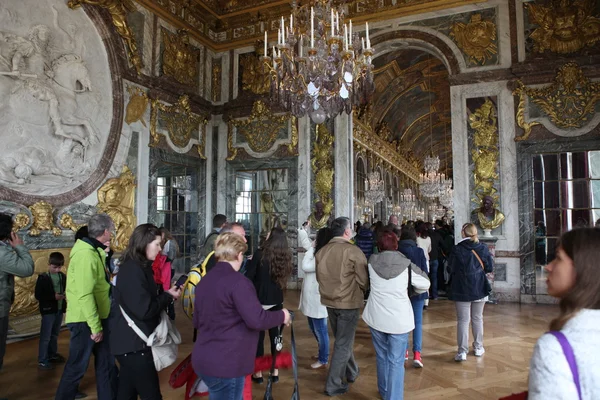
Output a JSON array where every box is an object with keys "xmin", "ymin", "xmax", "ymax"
[{"xmin": 135, "ymin": 0, "xmax": 481, "ymax": 51}]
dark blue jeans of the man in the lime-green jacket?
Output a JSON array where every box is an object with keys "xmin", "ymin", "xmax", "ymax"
[{"xmin": 56, "ymin": 319, "xmax": 117, "ymax": 400}]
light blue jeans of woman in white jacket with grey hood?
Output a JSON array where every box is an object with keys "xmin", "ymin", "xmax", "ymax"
[{"xmin": 368, "ymin": 328, "xmax": 408, "ymax": 400}]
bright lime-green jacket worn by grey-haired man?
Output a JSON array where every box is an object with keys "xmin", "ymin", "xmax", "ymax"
[{"xmin": 65, "ymin": 238, "xmax": 110, "ymax": 333}]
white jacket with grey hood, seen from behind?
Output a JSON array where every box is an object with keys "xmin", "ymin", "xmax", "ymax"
[{"xmin": 362, "ymin": 251, "xmax": 429, "ymax": 334}]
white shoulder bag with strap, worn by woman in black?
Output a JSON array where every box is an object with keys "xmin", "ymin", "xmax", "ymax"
[{"xmin": 119, "ymin": 306, "xmax": 181, "ymax": 371}]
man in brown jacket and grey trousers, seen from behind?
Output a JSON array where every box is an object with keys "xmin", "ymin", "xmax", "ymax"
[{"xmin": 316, "ymin": 217, "xmax": 369, "ymax": 396}]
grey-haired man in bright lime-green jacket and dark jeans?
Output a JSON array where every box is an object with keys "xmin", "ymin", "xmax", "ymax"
[{"xmin": 56, "ymin": 214, "xmax": 117, "ymax": 400}]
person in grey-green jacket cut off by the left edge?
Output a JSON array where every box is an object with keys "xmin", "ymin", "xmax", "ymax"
[{"xmin": 0, "ymin": 214, "xmax": 34, "ymax": 369}]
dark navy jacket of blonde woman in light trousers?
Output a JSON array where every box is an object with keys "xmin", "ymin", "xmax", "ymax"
[{"xmin": 448, "ymin": 239, "xmax": 494, "ymax": 301}]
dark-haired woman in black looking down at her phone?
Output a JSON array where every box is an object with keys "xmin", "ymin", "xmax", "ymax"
[{"xmin": 110, "ymin": 224, "xmax": 181, "ymax": 400}]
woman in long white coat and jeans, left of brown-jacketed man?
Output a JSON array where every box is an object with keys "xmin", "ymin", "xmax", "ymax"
[{"xmin": 300, "ymin": 228, "xmax": 333, "ymax": 369}]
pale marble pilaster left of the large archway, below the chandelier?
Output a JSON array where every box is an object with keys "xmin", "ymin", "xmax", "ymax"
[{"xmin": 334, "ymin": 113, "xmax": 354, "ymax": 221}]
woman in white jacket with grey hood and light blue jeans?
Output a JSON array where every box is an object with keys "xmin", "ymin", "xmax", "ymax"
[{"xmin": 363, "ymin": 231, "xmax": 429, "ymax": 400}]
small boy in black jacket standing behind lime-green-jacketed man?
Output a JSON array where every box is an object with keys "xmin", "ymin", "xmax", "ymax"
[{"xmin": 35, "ymin": 252, "xmax": 67, "ymax": 369}]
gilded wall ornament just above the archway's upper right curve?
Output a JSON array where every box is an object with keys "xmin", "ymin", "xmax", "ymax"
[{"xmin": 450, "ymin": 14, "xmax": 498, "ymax": 65}]
